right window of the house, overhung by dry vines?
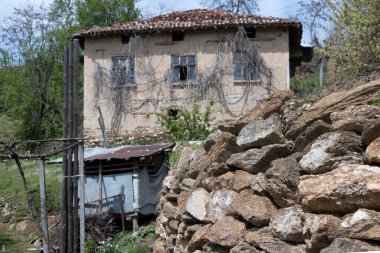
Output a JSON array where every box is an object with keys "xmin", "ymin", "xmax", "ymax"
[{"xmin": 234, "ymin": 51, "xmax": 258, "ymax": 81}]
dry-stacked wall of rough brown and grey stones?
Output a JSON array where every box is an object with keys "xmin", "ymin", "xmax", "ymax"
[{"xmin": 155, "ymin": 80, "xmax": 380, "ymax": 253}]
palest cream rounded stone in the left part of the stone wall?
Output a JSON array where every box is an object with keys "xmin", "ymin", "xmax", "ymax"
[{"xmin": 185, "ymin": 188, "xmax": 210, "ymax": 221}]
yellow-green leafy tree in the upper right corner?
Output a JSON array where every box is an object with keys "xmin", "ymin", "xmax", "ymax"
[{"xmin": 326, "ymin": 0, "xmax": 380, "ymax": 72}]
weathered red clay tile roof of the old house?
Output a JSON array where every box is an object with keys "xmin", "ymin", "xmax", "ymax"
[{"xmin": 73, "ymin": 9, "xmax": 301, "ymax": 38}]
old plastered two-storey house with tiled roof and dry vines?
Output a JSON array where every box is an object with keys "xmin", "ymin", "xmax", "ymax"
[{"xmin": 74, "ymin": 9, "xmax": 311, "ymax": 137}]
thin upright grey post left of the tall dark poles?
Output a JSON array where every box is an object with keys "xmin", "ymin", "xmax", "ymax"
[{"xmin": 40, "ymin": 160, "xmax": 49, "ymax": 253}]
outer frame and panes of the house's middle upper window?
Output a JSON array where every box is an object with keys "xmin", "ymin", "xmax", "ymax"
[{"xmin": 170, "ymin": 54, "xmax": 198, "ymax": 84}]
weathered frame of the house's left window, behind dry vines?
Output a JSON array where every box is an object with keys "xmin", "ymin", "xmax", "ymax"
[{"xmin": 110, "ymin": 55, "xmax": 137, "ymax": 87}]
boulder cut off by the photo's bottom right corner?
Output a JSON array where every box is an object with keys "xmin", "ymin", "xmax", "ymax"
[{"xmin": 320, "ymin": 238, "xmax": 380, "ymax": 253}]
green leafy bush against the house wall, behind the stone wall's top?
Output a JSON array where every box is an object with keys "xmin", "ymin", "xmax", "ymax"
[{"xmin": 156, "ymin": 102, "xmax": 211, "ymax": 141}]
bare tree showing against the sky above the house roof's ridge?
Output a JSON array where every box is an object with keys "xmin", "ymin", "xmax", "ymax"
[{"xmin": 201, "ymin": 0, "xmax": 259, "ymax": 14}]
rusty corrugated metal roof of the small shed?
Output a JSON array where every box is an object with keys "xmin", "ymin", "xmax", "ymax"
[{"xmin": 49, "ymin": 143, "xmax": 175, "ymax": 163}]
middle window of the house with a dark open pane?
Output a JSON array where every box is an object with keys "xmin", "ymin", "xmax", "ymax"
[{"xmin": 171, "ymin": 55, "xmax": 196, "ymax": 82}]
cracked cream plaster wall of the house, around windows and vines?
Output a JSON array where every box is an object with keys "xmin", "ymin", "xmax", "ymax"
[{"xmin": 84, "ymin": 28, "xmax": 289, "ymax": 137}]
